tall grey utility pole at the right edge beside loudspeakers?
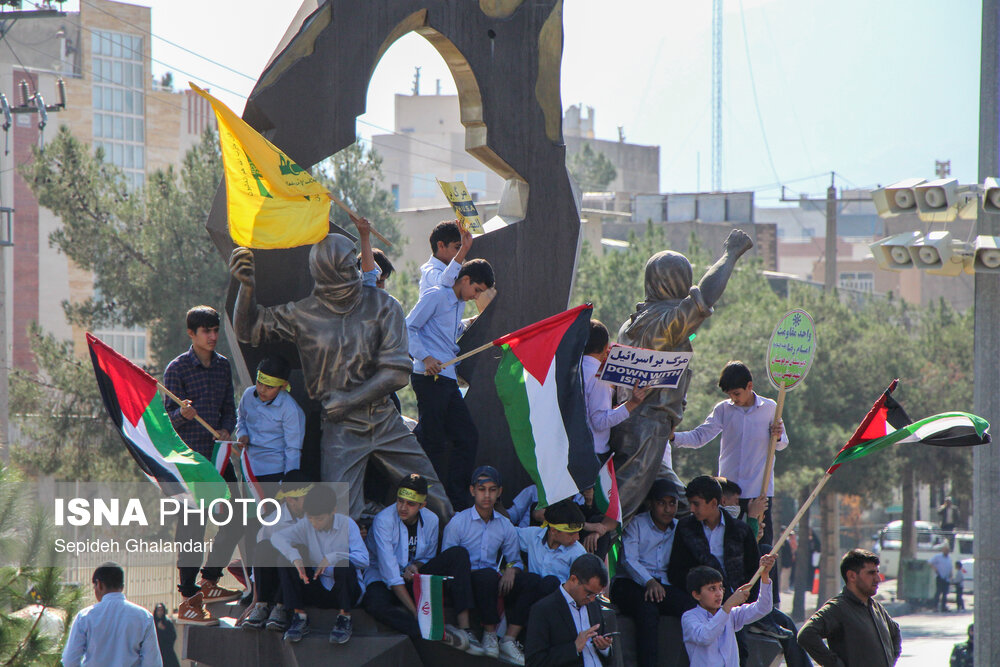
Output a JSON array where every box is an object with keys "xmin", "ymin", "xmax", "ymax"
[{"xmin": 972, "ymin": 0, "xmax": 1000, "ymax": 667}]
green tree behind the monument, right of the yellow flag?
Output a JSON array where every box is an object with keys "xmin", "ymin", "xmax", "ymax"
[{"xmin": 313, "ymin": 138, "xmax": 405, "ymax": 258}]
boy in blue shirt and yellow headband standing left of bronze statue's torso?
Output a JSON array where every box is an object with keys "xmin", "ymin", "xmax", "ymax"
[{"xmin": 236, "ymin": 356, "xmax": 306, "ymax": 482}]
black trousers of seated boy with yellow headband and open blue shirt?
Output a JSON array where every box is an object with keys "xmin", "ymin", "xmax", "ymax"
[{"xmin": 362, "ymin": 547, "xmax": 475, "ymax": 639}]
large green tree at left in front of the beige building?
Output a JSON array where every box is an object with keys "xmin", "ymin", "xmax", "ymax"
[{"xmin": 21, "ymin": 126, "xmax": 229, "ymax": 366}]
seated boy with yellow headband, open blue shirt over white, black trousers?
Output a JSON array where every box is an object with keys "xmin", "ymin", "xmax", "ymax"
[{"xmin": 363, "ymin": 473, "xmax": 483, "ymax": 655}]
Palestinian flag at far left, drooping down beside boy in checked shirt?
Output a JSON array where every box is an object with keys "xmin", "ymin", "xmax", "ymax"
[{"xmin": 87, "ymin": 333, "xmax": 229, "ymax": 504}]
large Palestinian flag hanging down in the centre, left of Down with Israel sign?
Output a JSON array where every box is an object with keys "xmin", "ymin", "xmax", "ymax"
[{"xmin": 493, "ymin": 304, "xmax": 598, "ymax": 507}]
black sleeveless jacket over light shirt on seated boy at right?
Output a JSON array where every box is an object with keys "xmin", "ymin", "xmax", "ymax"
[{"xmin": 667, "ymin": 514, "xmax": 760, "ymax": 591}]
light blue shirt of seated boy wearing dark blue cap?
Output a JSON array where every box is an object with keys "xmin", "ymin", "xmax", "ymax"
[{"xmin": 441, "ymin": 507, "xmax": 521, "ymax": 572}]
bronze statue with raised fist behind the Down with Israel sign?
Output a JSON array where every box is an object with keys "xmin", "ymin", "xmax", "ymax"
[{"xmin": 611, "ymin": 229, "xmax": 753, "ymax": 518}]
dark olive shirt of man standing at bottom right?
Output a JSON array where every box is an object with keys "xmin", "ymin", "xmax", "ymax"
[{"xmin": 799, "ymin": 587, "xmax": 902, "ymax": 667}]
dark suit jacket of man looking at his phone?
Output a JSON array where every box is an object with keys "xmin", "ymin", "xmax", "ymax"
[{"xmin": 524, "ymin": 589, "xmax": 614, "ymax": 667}]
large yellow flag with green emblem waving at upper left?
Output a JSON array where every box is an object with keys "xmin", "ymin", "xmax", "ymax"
[{"xmin": 188, "ymin": 83, "xmax": 330, "ymax": 249}]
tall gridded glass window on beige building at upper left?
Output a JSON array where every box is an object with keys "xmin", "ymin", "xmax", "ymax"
[{"xmin": 91, "ymin": 30, "xmax": 146, "ymax": 187}]
